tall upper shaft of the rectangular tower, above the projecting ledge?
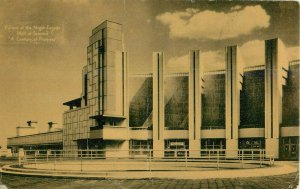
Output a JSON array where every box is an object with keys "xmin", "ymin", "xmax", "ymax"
[{"xmin": 87, "ymin": 21, "xmax": 126, "ymax": 116}]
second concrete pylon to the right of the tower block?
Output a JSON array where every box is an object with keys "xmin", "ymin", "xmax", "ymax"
[{"xmin": 189, "ymin": 50, "xmax": 203, "ymax": 157}]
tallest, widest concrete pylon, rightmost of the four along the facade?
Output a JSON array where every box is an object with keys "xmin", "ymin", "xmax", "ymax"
[{"xmin": 265, "ymin": 39, "xmax": 288, "ymax": 158}]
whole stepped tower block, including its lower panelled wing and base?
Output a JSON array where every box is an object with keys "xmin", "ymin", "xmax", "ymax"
[{"xmin": 63, "ymin": 21, "xmax": 128, "ymax": 150}]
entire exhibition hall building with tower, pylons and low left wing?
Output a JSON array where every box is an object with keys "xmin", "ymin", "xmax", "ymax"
[{"xmin": 8, "ymin": 21, "xmax": 299, "ymax": 159}]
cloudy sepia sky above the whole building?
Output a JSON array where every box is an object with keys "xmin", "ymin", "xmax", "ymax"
[{"xmin": 0, "ymin": 0, "xmax": 299, "ymax": 149}]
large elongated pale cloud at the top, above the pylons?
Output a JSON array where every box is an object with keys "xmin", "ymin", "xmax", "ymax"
[{"xmin": 156, "ymin": 5, "xmax": 270, "ymax": 40}]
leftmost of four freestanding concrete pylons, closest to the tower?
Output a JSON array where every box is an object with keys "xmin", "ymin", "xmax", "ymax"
[{"xmin": 153, "ymin": 52, "xmax": 165, "ymax": 157}]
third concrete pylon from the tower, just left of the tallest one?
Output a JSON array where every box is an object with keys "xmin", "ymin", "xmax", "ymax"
[{"xmin": 225, "ymin": 46, "xmax": 243, "ymax": 157}]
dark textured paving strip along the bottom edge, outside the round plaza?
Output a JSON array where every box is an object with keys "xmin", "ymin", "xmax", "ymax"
[{"xmin": 0, "ymin": 173, "xmax": 299, "ymax": 189}]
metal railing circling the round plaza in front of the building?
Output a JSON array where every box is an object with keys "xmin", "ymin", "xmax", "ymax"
[{"xmin": 19, "ymin": 149, "xmax": 274, "ymax": 171}]
